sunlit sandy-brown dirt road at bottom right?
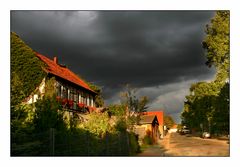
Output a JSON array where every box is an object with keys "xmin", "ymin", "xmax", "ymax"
[{"xmin": 138, "ymin": 133, "xmax": 229, "ymax": 157}]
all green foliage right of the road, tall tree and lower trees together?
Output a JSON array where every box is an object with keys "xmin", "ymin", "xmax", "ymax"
[{"xmin": 181, "ymin": 11, "xmax": 230, "ymax": 134}]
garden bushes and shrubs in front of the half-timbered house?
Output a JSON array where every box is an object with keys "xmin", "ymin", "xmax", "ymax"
[{"xmin": 11, "ymin": 96, "xmax": 139, "ymax": 156}]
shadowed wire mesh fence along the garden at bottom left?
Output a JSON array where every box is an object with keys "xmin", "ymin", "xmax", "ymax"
[{"xmin": 11, "ymin": 129, "xmax": 139, "ymax": 156}]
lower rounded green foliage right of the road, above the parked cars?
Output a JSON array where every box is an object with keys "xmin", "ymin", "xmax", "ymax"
[{"xmin": 182, "ymin": 82, "xmax": 229, "ymax": 133}]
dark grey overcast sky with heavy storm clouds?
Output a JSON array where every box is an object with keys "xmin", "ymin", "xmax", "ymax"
[{"xmin": 11, "ymin": 11, "xmax": 215, "ymax": 122}]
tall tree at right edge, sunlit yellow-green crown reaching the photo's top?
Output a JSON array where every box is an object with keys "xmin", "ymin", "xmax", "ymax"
[{"xmin": 203, "ymin": 11, "xmax": 230, "ymax": 133}]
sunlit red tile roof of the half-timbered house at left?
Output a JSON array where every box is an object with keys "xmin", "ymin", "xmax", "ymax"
[{"xmin": 36, "ymin": 53, "xmax": 95, "ymax": 93}]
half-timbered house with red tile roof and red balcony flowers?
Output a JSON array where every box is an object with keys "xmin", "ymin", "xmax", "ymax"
[{"xmin": 26, "ymin": 53, "xmax": 96, "ymax": 112}]
